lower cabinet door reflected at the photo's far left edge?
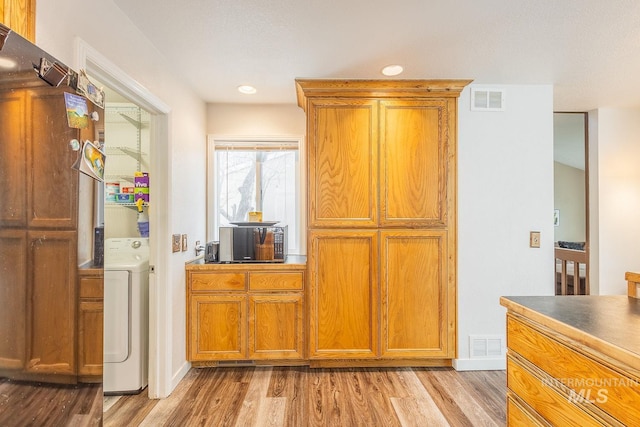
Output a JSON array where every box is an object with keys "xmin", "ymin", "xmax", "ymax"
[{"xmin": 0, "ymin": 229, "xmax": 27, "ymax": 375}]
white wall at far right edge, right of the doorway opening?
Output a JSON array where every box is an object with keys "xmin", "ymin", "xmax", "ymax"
[{"xmin": 589, "ymin": 108, "xmax": 640, "ymax": 295}]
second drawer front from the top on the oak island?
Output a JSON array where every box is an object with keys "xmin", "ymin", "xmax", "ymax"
[{"xmin": 507, "ymin": 356, "xmax": 606, "ymax": 427}]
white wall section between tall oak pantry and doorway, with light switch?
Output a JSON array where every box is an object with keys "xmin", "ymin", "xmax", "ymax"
[{"xmin": 455, "ymin": 85, "xmax": 554, "ymax": 370}]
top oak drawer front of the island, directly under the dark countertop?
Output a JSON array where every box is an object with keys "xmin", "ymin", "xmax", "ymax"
[{"xmin": 507, "ymin": 315, "xmax": 640, "ymax": 425}]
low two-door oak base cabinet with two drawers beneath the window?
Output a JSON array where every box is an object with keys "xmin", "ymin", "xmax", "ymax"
[{"xmin": 186, "ymin": 263, "xmax": 306, "ymax": 366}]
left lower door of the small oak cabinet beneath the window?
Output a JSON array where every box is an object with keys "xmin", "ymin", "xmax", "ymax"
[{"xmin": 188, "ymin": 295, "xmax": 247, "ymax": 361}]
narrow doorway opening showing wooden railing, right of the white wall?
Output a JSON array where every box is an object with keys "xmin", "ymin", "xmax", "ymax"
[{"xmin": 553, "ymin": 112, "xmax": 590, "ymax": 295}]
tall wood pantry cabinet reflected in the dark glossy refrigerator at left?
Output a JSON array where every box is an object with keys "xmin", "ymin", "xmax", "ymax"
[{"xmin": 0, "ymin": 79, "xmax": 100, "ymax": 383}]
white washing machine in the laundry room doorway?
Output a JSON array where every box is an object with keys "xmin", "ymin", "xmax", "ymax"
[{"xmin": 103, "ymin": 238, "xmax": 149, "ymax": 394}]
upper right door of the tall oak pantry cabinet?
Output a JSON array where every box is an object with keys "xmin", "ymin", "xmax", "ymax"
[{"xmin": 380, "ymin": 99, "xmax": 455, "ymax": 227}]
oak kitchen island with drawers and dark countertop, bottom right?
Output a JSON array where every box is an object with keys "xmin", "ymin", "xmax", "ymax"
[{"xmin": 500, "ymin": 296, "xmax": 640, "ymax": 427}]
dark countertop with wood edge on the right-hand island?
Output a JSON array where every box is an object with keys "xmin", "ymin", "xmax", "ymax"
[{"xmin": 500, "ymin": 295, "xmax": 640, "ymax": 370}]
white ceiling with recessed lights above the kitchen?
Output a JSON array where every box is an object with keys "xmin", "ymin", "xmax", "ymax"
[{"xmin": 114, "ymin": 0, "xmax": 640, "ymax": 111}]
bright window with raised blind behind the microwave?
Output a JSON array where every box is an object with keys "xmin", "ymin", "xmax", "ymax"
[{"xmin": 208, "ymin": 136, "xmax": 303, "ymax": 254}]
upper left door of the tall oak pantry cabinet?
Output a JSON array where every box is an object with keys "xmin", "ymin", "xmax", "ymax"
[{"xmin": 307, "ymin": 99, "xmax": 378, "ymax": 228}]
